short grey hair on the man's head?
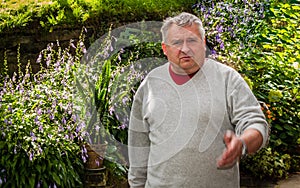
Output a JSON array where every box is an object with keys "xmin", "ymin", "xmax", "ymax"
[{"xmin": 160, "ymin": 12, "xmax": 205, "ymax": 42}]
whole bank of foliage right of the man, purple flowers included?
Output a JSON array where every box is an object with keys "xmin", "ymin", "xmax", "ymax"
[{"xmin": 195, "ymin": 0, "xmax": 300, "ymax": 179}]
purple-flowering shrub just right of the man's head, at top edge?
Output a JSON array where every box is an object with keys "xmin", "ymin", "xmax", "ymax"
[{"xmin": 194, "ymin": 0, "xmax": 268, "ymax": 64}]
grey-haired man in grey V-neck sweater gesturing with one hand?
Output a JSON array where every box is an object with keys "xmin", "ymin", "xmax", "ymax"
[{"xmin": 128, "ymin": 13, "xmax": 269, "ymax": 188}]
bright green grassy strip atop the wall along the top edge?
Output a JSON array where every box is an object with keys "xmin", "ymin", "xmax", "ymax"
[{"xmin": 0, "ymin": 0, "xmax": 194, "ymax": 32}]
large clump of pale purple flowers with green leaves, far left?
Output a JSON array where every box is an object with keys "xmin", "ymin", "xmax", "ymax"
[{"xmin": 0, "ymin": 39, "xmax": 83, "ymax": 187}]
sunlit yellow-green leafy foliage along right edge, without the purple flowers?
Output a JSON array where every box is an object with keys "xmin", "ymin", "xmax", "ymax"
[{"xmin": 241, "ymin": 2, "xmax": 300, "ymax": 154}]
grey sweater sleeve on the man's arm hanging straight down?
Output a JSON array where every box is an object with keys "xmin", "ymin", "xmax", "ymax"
[{"xmin": 128, "ymin": 83, "xmax": 150, "ymax": 187}]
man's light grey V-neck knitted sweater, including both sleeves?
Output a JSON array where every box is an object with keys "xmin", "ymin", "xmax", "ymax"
[{"xmin": 128, "ymin": 59, "xmax": 268, "ymax": 188}]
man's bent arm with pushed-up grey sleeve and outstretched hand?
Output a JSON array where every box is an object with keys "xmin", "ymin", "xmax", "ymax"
[{"xmin": 217, "ymin": 72, "xmax": 269, "ymax": 168}]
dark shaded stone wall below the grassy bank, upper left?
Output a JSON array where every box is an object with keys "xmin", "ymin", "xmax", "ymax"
[{"xmin": 0, "ymin": 24, "xmax": 103, "ymax": 75}]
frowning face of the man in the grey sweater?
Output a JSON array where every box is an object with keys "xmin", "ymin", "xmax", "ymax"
[{"xmin": 162, "ymin": 24, "xmax": 205, "ymax": 74}]
